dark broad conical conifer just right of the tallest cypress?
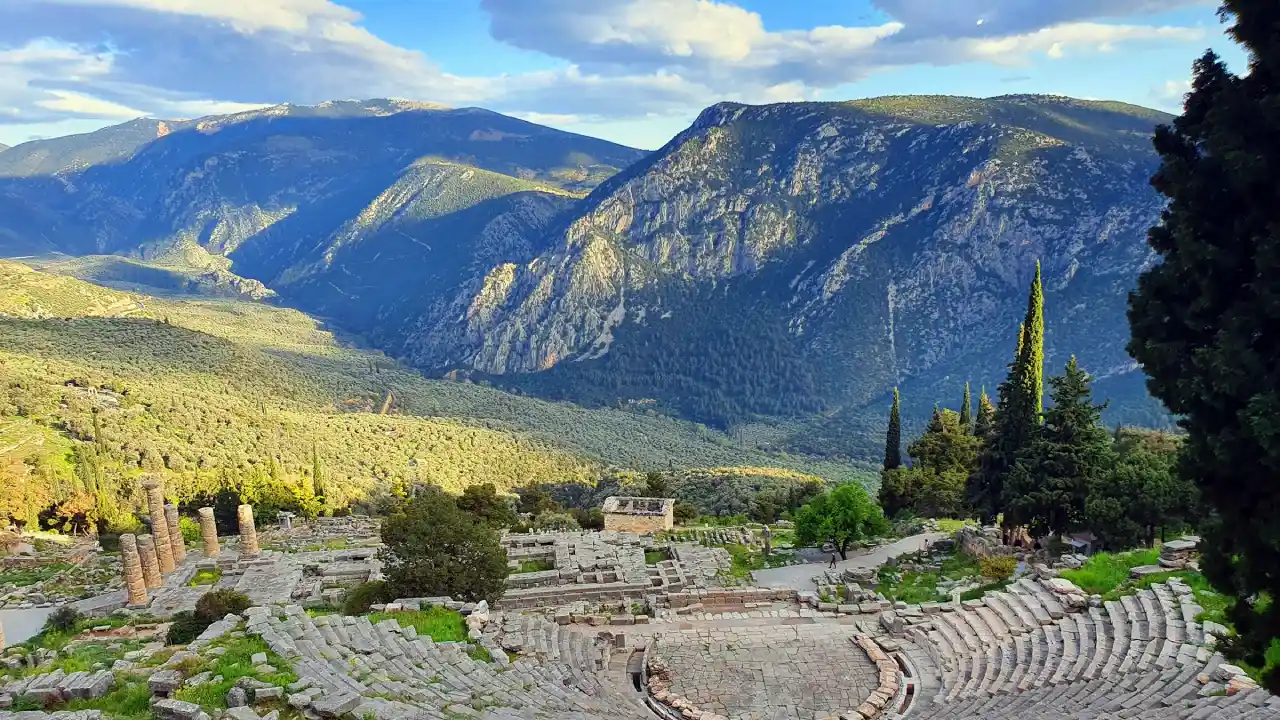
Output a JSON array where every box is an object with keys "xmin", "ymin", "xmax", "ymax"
[{"xmin": 1004, "ymin": 356, "xmax": 1115, "ymax": 534}]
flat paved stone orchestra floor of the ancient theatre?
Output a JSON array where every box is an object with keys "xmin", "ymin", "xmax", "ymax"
[{"xmin": 657, "ymin": 625, "xmax": 878, "ymax": 720}]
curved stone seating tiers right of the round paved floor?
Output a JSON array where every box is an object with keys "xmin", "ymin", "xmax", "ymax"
[{"xmin": 908, "ymin": 579, "xmax": 1280, "ymax": 720}]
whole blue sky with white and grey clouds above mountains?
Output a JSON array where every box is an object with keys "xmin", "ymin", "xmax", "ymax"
[{"xmin": 0, "ymin": 0, "xmax": 1245, "ymax": 149}]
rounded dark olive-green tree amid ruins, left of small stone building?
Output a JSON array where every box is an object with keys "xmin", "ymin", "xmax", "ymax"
[{"xmin": 380, "ymin": 488, "xmax": 507, "ymax": 602}]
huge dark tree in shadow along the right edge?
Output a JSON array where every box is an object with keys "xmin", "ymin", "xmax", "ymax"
[{"xmin": 1129, "ymin": 0, "xmax": 1280, "ymax": 692}]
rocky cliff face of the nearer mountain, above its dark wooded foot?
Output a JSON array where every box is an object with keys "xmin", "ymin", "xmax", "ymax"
[{"xmin": 408, "ymin": 97, "xmax": 1161, "ymax": 438}]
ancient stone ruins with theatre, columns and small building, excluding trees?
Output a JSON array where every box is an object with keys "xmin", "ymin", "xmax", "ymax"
[{"xmin": 0, "ymin": 476, "xmax": 1280, "ymax": 720}]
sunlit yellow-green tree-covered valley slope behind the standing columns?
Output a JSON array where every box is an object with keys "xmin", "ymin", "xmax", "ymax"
[{"xmin": 0, "ymin": 261, "xmax": 875, "ymax": 530}]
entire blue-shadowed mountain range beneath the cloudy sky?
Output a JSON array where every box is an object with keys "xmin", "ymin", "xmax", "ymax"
[{"xmin": 0, "ymin": 96, "xmax": 1170, "ymax": 456}]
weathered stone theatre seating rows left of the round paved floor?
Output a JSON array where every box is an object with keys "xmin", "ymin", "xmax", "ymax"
[{"xmin": 240, "ymin": 606, "xmax": 649, "ymax": 720}]
